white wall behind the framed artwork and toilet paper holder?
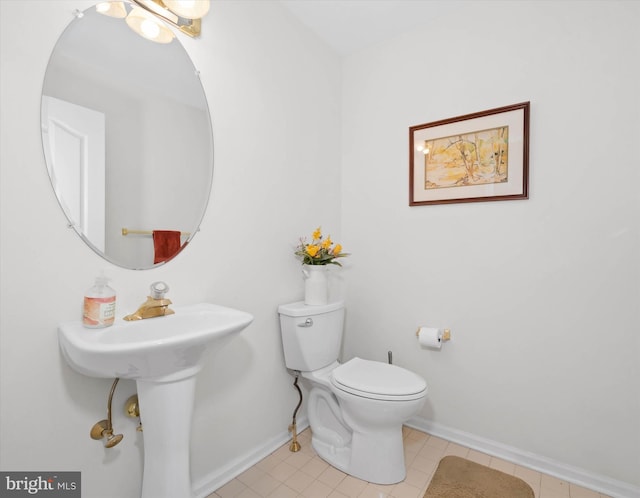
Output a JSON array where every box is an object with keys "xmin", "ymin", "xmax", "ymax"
[{"xmin": 342, "ymin": 2, "xmax": 640, "ymax": 496}]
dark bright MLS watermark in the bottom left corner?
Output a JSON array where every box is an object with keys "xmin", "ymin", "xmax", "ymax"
[{"xmin": 0, "ymin": 472, "xmax": 82, "ymax": 498}]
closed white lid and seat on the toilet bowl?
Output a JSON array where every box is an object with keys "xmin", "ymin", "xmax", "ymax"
[{"xmin": 331, "ymin": 358, "xmax": 427, "ymax": 401}]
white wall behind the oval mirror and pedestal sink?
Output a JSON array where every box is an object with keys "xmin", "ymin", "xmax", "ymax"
[{"xmin": 0, "ymin": 0, "xmax": 340, "ymax": 498}]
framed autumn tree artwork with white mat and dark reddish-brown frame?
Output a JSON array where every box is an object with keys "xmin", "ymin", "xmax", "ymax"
[{"xmin": 409, "ymin": 102, "xmax": 529, "ymax": 206}]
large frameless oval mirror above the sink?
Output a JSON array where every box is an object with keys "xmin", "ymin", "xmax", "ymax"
[{"xmin": 41, "ymin": 3, "xmax": 213, "ymax": 269}]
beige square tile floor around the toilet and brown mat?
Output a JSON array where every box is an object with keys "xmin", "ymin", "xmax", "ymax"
[{"xmin": 208, "ymin": 427, "xmax": 608, "ymax": 498}]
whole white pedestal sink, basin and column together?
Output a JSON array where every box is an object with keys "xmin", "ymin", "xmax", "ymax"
[{"xmin": 58, "ymin": 303, "xmax": 253, "ymax": 498}]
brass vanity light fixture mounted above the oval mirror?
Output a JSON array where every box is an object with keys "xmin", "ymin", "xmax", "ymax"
[{"xmin": 131, "ymin": 0, "xmax": 210, "ymax": 38}]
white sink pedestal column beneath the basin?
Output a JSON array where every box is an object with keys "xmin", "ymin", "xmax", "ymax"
[{"xmin": 136, "ymin": 372, "xmax": 196, "ymax": 498}]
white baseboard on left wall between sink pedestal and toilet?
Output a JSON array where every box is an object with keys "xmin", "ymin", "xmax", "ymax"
[{"xmin": 193, "ymin": 417, "xmax": 309, "ymax": 498}]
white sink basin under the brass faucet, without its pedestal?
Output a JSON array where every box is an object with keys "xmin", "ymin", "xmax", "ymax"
[{"xmin": 58, "ymin": 303, "xmax": 253, "ymax": 379}]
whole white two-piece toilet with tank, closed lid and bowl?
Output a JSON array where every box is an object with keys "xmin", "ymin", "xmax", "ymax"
[{"xmin": 278, "ymin": 302, "xmax": 427, "ymax": 484}]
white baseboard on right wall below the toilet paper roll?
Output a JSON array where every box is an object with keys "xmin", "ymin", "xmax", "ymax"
[{"xmin": 405, "ymin": 417, "xmax": 640, "ymax": 498}]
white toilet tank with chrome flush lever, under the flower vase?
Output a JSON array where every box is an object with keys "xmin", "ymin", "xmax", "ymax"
[{"xmin": 278, "ymin": 301, "xmax": 344, "ymax": 372}]
